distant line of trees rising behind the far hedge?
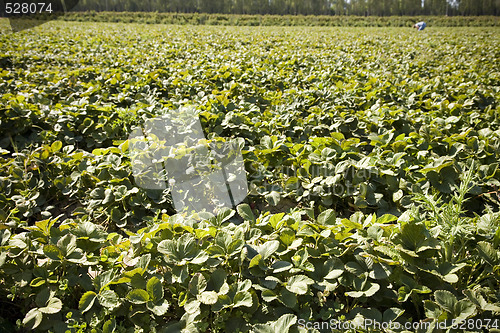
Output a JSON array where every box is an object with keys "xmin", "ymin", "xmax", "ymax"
[{"xmin": 74, "ymin": 0, "xmax": 500, "ymax": 16}]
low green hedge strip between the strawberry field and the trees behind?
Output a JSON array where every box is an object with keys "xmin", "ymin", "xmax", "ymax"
[{"xmin": 57, "ymin": 11, "xmax": 498, "ymax": 27}]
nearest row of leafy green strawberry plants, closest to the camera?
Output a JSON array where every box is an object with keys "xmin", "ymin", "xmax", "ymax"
[{"xmin": 0, "ymin": 182, "xmax": 500, "ymax": 332}]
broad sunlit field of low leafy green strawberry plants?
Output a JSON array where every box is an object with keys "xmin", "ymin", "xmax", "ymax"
[{"xmin": 0, "ymin": 21, "xmax": 500, "ymax": 333}]
